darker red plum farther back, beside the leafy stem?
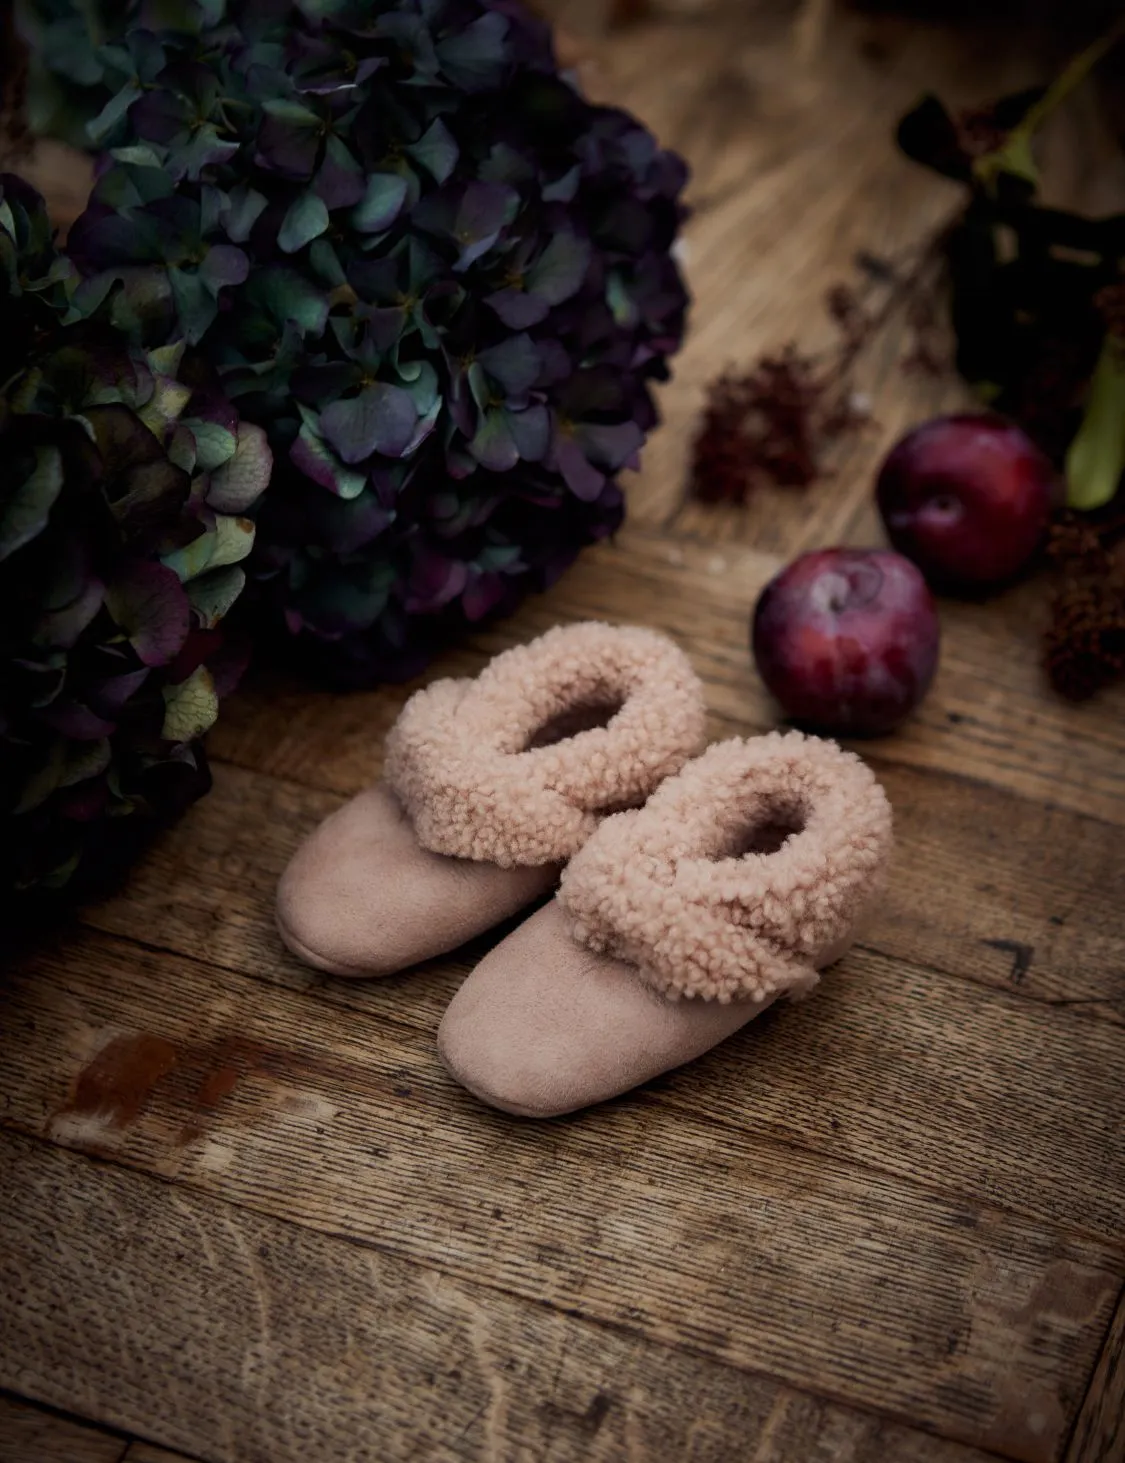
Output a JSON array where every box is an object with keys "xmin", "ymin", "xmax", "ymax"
[{"xmin": 875, "ymin": 413, "xmax": 1056, "ymax": 590}]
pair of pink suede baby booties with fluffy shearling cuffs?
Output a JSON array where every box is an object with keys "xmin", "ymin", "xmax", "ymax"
[{"xmin": 276, "ymin": 623, "xmax": 891, "ymax": 1116}]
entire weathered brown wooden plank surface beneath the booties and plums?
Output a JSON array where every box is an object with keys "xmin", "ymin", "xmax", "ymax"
[{"xmin": 0, "ymin": 0, "xmax": 1125, "ymax": 1463}]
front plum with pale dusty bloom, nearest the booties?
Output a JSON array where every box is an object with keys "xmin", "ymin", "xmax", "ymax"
[{"xmin": 752, "ymin": 549, "xmax": 941, "ymax": 736}]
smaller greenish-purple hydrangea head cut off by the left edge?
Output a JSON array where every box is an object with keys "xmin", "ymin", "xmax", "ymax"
[{"xmin": 0, "ymin": 177, "xmax": 271, "ymax": 901}]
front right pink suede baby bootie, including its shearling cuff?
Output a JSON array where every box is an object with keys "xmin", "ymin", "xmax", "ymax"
[{"xmin": 437, "ymin": 732, "xmax": 891, "ymax": 1116}]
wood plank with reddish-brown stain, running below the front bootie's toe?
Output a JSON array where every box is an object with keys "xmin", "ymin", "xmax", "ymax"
[{"xmin": 3, "ymin": 924, "xmax": 1125, "ymax": 1463}]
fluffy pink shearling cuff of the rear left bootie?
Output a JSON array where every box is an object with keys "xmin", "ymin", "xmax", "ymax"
[{"xmin": 383, "ymin": 622, "xmax": 705, "ymax": 868}]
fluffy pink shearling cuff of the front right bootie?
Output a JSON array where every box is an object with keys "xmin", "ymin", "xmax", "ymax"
[{"xmin": 559, "ymin": 732, "xmax": 891, "ymax": 1002}]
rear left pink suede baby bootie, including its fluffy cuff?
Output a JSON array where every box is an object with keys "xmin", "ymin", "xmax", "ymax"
[{"xmin": 276, "ymin": 623, "xmax": 705, "ymax": 976}]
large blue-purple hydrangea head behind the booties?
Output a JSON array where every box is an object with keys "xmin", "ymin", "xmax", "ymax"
[{"xmin": 63, "ymin": 0, "xmax": 686, "ymax": 682}]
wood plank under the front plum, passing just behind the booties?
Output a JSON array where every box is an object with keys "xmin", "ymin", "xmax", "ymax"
[{"xmin": 550, "ymin": 533, "xmax": 1125, "ymax": 822}]
